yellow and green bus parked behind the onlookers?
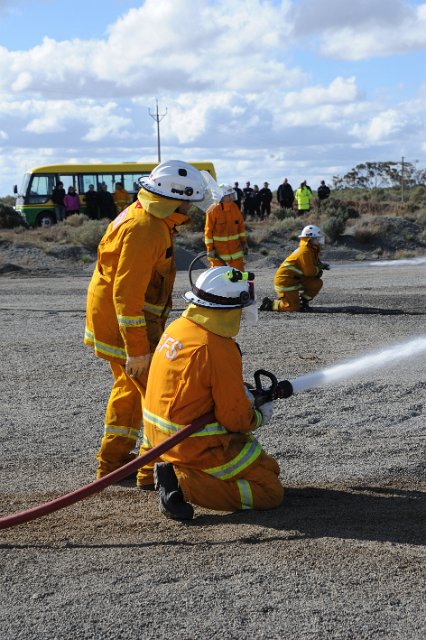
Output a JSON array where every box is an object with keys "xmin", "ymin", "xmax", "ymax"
[{"xmin": 13, "ymin": 162, "xmax": 216, "ymax": 227}]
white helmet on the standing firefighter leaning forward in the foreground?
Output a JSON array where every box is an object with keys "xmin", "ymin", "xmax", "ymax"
[{"xmin": 139, "ymin": 160, "xmax": 206, "ymax": 202}]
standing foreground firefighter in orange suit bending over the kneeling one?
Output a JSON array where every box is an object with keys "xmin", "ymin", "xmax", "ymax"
[{"xmin": 84, "ymin": 160, "xmax": 206, "ymax": 478}]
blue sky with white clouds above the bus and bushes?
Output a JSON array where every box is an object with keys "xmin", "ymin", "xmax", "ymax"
[{"xmin": 0, "ymin": 0, "xmax": 426, "ymax": 195}]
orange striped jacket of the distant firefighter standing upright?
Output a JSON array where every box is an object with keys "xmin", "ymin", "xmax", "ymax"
[{"xmin": 204, "ymin": 202, "xmax": 247, "ymax": 262}]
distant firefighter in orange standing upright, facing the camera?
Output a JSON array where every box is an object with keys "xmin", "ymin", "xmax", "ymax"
[{"xmin": 204, "ymin": 185, "xmax": 247, "ymax": 270}]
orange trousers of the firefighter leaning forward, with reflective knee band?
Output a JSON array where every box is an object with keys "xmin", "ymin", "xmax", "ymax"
[{"xmin": 96, "ymin": 362, "xmax": 148, "ymax": 478}]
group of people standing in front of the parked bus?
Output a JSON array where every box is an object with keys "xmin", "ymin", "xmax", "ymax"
[{"xmin": 52, "ymin": 182, "xmax": 132, "ymax": 222}]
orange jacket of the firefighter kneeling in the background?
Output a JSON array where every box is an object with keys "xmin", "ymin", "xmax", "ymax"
[{"xmin": 274, "ymin": 238, "xmax": 321, "ymax": 297}]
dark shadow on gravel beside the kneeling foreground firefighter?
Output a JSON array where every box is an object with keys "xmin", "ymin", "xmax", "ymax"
[{"xmin": 197, "ymin": 486, "xmax": 426, "ymax": 545}]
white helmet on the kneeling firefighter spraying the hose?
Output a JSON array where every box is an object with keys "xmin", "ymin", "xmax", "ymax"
[{"xmin": 184, "ymin": 266, "xmax": 254, "ymax": 309}]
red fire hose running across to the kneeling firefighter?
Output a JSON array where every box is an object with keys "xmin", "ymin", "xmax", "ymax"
[{"xmin": 0, "ymin": 413, "xmax": 215, "ymax": 529}]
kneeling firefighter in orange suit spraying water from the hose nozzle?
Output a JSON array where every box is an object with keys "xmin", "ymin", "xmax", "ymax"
[{"xmin": 138, "ymin": 266, "xmax": 284, "ymax": 520}]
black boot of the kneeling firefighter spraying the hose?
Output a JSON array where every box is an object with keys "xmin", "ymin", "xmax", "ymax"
[{"xmin": 154, "ymin": 462, "xmax": 194, "ymax": 520}]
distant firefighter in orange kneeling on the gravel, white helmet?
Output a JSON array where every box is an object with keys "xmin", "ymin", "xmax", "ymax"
[{"xmin": 260, "ymin": 224, "xmax": 329, "ymax": 311}]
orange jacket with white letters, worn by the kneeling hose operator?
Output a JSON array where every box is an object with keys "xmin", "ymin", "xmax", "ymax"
[{"xmin": 141, "ymin": 312, "xmax": 262, "ymax": 480}]
